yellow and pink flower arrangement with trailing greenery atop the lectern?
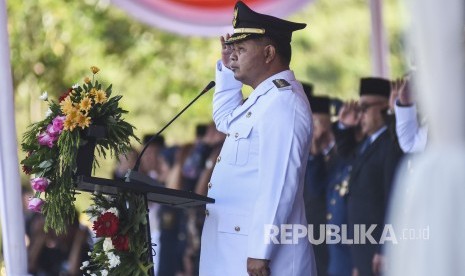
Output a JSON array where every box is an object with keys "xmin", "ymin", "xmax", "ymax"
[{"xmin": 21, "ymin": 66, "xmax": 139, "ymax": 233}]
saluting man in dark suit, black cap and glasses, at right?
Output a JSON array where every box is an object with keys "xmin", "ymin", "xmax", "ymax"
[{"xmin": 336, "ymin": 77, "xmax": 402, "ymax": 276}]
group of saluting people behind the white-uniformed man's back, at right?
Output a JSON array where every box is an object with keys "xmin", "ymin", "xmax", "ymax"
[{"xmin": 304, "ymin": 72, "xmax": 427, "ymax": 276}]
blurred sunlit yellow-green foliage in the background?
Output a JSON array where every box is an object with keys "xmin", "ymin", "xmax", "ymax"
[{"xmin": 0, "ymin": 0, "xmax": 409, "ymax": 274}]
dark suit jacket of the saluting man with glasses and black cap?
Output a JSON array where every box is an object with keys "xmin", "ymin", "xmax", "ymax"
[{"xmin": 336, "ymin": 126, "xmax": 402, "ymax": 275}]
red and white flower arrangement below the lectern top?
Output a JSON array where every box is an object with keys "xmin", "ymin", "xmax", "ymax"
[{"xmin": 81, "ymin": 193, "xmax": 153, "ymax": 276}]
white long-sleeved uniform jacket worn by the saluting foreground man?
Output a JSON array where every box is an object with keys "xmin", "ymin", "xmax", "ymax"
[{"xmin": 200, "ymin": 61, "xmax": 316, "ymax": 276}]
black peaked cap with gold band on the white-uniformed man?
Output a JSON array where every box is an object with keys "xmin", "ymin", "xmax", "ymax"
[{"xmin": 225, "ymin": 1, "xmax": 307, "ymax": 44}]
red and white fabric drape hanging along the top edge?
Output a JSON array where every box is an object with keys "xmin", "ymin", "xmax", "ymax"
[{"xmin": 112, "ymin": 0, "xmax": 312, "ymax": 36}]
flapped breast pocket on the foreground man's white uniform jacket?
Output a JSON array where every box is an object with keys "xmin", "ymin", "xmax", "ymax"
[{"xmin": 229, "ymin": 125, "xmax": 252, "ymax": 166}]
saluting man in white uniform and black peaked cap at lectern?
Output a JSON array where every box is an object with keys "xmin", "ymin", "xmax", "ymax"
[{"xmin": 200, "ymin": 2, "xmax": 316, "ymax": 276}]
